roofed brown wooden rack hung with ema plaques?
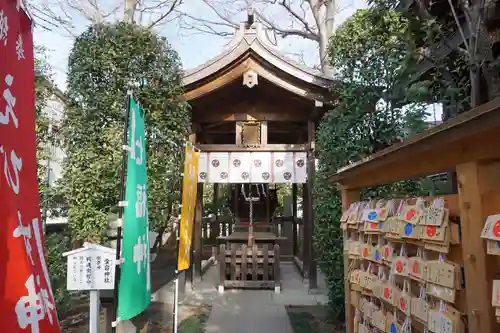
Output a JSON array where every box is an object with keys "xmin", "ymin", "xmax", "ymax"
[{"xmin": 332, "ymin": 99, "xmax": 500, "ymax": 333}]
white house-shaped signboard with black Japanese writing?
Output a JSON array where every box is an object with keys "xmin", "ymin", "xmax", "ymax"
[{"xmin": 63, "ymin": 243, "xmax": 116, "ymax": 290}]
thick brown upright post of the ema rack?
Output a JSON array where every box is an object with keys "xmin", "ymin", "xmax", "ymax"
[{"xmin": 457, "ymin": 162, "xmax": 500, "ymax": 332}]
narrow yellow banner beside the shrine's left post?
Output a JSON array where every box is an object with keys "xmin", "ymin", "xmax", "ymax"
[{"xmin": 177, "ymin": 144, "xmax": 200, "ymax": 272}]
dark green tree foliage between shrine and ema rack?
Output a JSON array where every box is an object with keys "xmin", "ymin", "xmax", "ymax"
[{"xmin": 314, "ymin": 6, "xmax": 428, "ymax": 315}]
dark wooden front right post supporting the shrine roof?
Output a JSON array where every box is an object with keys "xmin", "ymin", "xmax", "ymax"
[{"xmin": 304, "ymin": 120, "xmax": 318, "ymax": 289}]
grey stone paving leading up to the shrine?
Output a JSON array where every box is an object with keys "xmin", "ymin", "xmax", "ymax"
[{"xmin": 176, "ymin": 263, "xmax": 328, "ymax": 333}]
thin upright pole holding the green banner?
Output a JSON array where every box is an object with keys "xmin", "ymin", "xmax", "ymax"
[{"xmin": 111, "ymin": 91, "xmax": 132, "ymax": 333}]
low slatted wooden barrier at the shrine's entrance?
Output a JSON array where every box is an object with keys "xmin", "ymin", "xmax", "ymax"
[{"xmin": 218, "ymin": 244, "xmax": 281, "ymax": 293}]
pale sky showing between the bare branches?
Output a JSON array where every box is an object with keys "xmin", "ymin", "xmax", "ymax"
[{"xmin": 30, "ymin": 0, "xmax": 441, "ymax": 121}]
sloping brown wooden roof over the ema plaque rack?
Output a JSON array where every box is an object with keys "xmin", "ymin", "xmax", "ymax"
[{"xmin": 331, "ymin": 98, "xmax": 500, "ymax": 189}]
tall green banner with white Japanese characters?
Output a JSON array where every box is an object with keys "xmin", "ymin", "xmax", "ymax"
[{"xmin": 118, "ymin": 93, "xmax": 151, "ymax": 320}]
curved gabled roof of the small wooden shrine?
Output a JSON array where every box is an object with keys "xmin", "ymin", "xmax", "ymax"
[{"xmin": 183, "ymin": 22, "xmax": 334, "ymax": 103}]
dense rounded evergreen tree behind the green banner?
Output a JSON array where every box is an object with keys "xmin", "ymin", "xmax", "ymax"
[{"xmin": 63, "ymin": 23, "xmax": 190, "ymax": 241}]
